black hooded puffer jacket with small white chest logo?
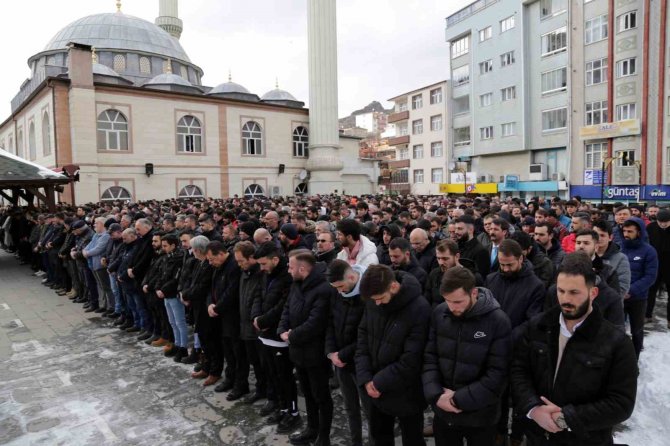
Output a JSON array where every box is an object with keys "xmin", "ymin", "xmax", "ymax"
[{"xmin": 423, "ymin": 288, "xmax": 512, "ymax": 427}]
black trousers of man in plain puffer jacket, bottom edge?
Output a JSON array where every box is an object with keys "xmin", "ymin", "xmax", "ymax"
[{"xmin": 370, "ymin": 402, "xmax": 426, "ymax": 446}]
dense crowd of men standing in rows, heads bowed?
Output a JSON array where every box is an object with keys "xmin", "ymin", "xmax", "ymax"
[{"xmin": 0, "ymin": 196, "xmax": 670, "ymax": 446}]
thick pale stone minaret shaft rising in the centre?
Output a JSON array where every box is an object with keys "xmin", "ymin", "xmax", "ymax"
[{"xmin": 306, "ymin": 0, "xmax": 343, "ymax": 194}]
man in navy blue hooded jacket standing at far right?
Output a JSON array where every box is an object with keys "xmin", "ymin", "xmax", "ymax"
[{"xmin": 621, "ymin": 217, "xmax": 658, "ymax": 358}]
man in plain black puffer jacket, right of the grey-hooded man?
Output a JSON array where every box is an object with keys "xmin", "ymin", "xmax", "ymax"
[{"xmin": 355, "ymin": 265, "xmax": 430, "ymax": 446}]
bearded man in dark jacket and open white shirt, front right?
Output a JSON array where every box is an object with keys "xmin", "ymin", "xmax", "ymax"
[{"xmin": 510, "ymin": 253, "xmax": 638, "ymax": 446}]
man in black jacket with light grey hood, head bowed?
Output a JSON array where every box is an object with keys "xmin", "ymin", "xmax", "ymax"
[{"xmin": 326, "ymin": 259, "xmax": 371, "ymax": 446}]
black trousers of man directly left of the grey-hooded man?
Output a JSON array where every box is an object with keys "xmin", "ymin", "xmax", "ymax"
[{"xmin": 296, "ymin": 361, "xmax": 333, "ymax": 438}]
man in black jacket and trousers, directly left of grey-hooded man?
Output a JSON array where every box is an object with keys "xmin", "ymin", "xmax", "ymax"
[{"xmin": 277, "ymin": 249, "xmax": 335, "ymax": 446}]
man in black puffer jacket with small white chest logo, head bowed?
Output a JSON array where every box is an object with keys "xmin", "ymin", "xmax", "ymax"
[{"xmin": 423, "ymin": 268, "xmax": 512, "ymax": 446}]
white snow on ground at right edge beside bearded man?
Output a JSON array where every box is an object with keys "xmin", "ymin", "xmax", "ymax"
[{"xmin": 615, "ymin": 331, "xmax": 670, "ymax": 446}]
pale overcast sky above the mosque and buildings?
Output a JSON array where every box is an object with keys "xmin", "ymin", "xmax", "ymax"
[{"xmin": 0, "ymin": 0, "xmax": 470, "ymax": 121}]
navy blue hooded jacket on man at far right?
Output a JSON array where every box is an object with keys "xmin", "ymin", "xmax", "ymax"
[{"xmin": 621, "ymin": 217, "xmax": 658, "ymax": 301}]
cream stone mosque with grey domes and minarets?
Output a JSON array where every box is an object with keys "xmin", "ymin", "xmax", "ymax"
[{"xmin": 0, "ymin": 0, "xmax": 378, "ymax": 203}]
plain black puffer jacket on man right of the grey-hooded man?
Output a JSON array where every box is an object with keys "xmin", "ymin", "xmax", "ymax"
[{"xmin": 355, "ymin": 271, "xmax": 431, "ymax": 416}]
